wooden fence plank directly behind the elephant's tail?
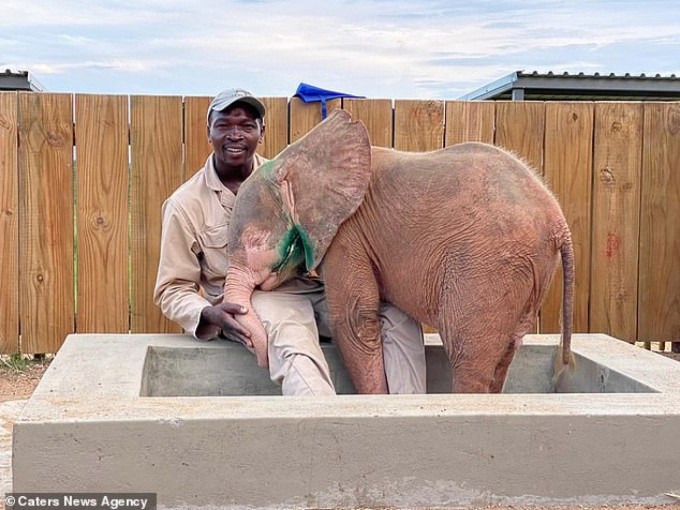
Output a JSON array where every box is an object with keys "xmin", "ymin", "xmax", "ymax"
[{"xmin": 540, "ymin": 103, "xmax": 595, "ymax": 333}]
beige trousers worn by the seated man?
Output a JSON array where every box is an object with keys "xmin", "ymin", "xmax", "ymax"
[{"xmin": 252, "ymin": 278, "xmax": 426, "ymax": 395}]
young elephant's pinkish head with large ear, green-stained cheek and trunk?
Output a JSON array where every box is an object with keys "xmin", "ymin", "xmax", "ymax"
[{"xmin": 224, "ymin": 110, "xmax": 371, "ymax": 366}]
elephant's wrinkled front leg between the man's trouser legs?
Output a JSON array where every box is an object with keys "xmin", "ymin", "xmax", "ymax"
[{"xmin": 322, "ymin": 237, "xmax": 388, "ymax": 394}]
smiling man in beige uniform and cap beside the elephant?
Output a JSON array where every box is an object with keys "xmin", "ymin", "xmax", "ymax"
[{"xmin": 154, "ymin": 89, "xmax": 425, "ymax": 395}]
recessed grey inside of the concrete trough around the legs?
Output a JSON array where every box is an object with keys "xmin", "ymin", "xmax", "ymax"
[{"xmin": 140, "ymin": 344, "xmax": 655, "ymax": 397}]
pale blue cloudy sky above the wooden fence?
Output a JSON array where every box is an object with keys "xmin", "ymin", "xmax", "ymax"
[{"xmin": 0, "ymin": 0, "xmax": 680, "ymax": 99}]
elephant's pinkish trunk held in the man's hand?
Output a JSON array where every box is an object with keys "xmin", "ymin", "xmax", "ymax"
[{"xmin": 224, "ymin": 266, "xmax": 269, "ymax": 368}]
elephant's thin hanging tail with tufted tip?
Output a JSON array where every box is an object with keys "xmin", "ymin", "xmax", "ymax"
[{"xmin": 553, "ymin": 234, "xmax": 575, "ymax": 384}]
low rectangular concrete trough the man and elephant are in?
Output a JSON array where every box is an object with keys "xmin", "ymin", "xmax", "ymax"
[{"xmin": 13, "ymin": 334, "xmax": 680, "ymax": 508}]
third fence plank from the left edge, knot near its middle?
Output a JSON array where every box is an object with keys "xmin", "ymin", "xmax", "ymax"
[{"xmin": 75, "ymin": 94, "xmax": 130, "ymax": 333}]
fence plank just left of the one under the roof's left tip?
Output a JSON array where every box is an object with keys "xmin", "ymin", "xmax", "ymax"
[{"xmin": 394, "ymin": 100, "xmax": 444, "ymax": 152}]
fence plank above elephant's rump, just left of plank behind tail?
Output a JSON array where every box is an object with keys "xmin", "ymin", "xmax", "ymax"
[{"xmin": 495, "ymin": 101, "xmax": 545, "ymax": 175}]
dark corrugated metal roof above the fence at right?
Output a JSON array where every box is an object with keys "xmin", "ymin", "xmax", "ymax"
[{"xmin": 459, "ymin": 71, "xmax": 680, "ymax": 101}]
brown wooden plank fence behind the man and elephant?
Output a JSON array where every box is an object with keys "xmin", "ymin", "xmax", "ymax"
[{"xmin": 0, "ymin": 92, "xmax": 680, "ymax": 353}]
